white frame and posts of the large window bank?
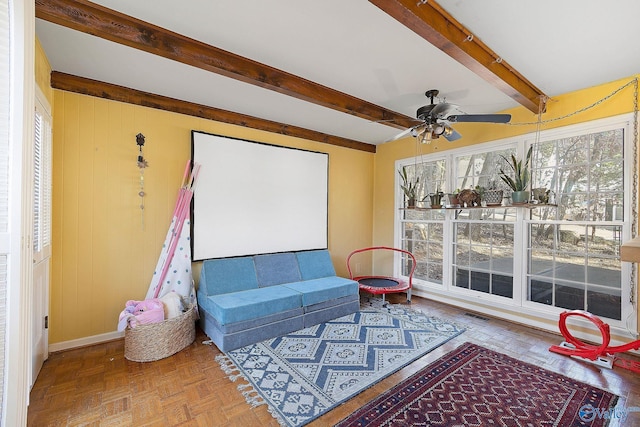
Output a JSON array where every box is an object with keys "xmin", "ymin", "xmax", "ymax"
[{"xmin": 393, "ymin": 113, "xmax": 638, "ymax": 333}]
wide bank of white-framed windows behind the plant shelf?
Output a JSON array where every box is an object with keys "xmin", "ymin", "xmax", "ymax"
[{"xmin": 396, "ymin": 117, "xmax": 633, "ymax": 326}]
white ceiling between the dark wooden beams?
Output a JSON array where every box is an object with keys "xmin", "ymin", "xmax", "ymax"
[{"xmin": 36, "ymin": 0, "xmax": 640, "ymax": 144}]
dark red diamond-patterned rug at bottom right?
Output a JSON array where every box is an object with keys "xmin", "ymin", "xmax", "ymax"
[{"xmin": 336, "ymin": 343, "xmax": 618, "ymax": 427}]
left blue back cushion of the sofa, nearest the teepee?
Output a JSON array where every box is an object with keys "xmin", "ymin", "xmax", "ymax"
[{"xmin": 200, "ymin": 257, "xmax": 258, "ymax": 295}]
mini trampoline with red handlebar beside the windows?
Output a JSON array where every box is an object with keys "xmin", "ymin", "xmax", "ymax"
[{"xmin": 347, "ymin": 246, "xmax": 416, "ymax": 305}]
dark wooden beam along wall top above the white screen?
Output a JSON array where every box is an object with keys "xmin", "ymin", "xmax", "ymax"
[{"xmin": 51, "ymin": 71, "xmax": 376, "ymax": 153}]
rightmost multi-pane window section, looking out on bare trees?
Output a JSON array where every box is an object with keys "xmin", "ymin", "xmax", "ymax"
[{"xmin": 527, "ymin": 128, "xmax": 625, "ymax": 320}]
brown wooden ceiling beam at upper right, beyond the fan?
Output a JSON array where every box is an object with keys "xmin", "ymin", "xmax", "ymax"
[{"xmin": 369, "ymin": 0, "xmax": 548, "ymax": 114}]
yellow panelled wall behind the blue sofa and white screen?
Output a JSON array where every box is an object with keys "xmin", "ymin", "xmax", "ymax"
[{"xmin": 49, "ymin": 90, "xmax": 374, "ymax": 343}]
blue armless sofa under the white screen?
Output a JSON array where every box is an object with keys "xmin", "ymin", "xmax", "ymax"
[{"xmin": 197, "ymin": 250, "xmax": 360, "ymax": 352}]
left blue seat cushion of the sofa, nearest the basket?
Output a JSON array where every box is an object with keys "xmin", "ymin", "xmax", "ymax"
[{"xmin": 208, "ymin": 286, "xmax": 302, "ymax": 325}]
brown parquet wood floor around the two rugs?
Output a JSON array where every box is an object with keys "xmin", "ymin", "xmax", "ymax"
[{"xmin": 28, "ymin": 295, "xmax": 640, "ymax": 427}]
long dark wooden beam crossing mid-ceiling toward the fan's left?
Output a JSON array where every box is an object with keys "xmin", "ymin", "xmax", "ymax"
[{"xmin": 35, "ymin": 0, "xmax": 416, "ymax": 129}]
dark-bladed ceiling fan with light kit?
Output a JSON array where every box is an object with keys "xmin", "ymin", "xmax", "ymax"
[{"xmin": 393, "ymin": 89, "xmax": 511, "ymax": 144}]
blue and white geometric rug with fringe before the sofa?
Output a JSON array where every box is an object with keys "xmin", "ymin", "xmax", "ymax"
[{"xmin": 216, "ymin": 300, "xmax": 464, "ymax": 427}]
